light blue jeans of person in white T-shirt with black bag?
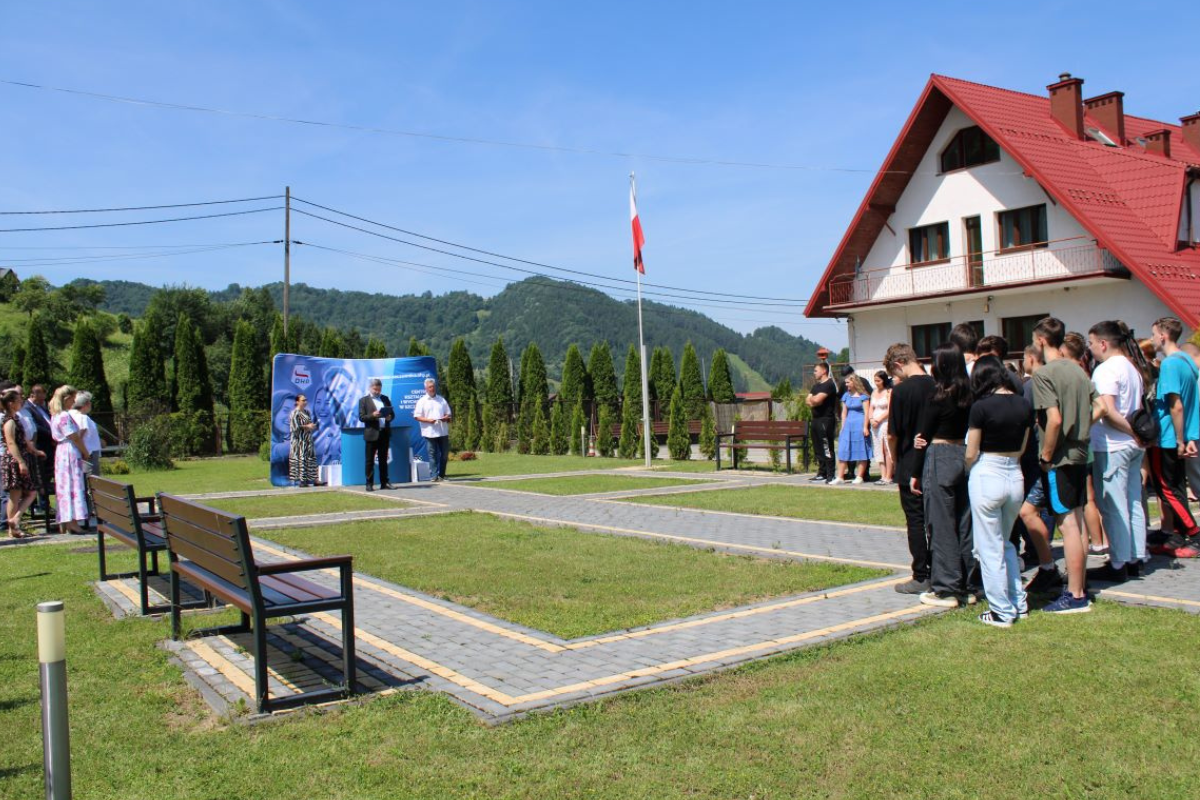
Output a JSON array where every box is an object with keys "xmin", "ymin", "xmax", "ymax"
[{"xmin": 1092, "ymin": 447, "xmax": 1146, "ymax": 567}]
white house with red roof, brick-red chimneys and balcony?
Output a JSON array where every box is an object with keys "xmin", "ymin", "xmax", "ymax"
[{"xmin": 805, "ymin": 74, "xmax": 1200, "ymax": 363}]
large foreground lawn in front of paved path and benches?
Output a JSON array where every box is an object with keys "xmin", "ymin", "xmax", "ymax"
[{"xmin": 0, "ymin": 546, "xmax": 1200, "ymax": 800}]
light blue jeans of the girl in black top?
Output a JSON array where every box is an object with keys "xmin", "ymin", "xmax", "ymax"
[{"xmin": 967, "ymin": 453, "xmax": 1030, "ymax": 621}]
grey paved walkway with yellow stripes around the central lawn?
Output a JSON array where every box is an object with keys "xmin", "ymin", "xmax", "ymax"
[{"xmin": 91, "ymin": 471, "xmax": 1200, "ymax": 722}]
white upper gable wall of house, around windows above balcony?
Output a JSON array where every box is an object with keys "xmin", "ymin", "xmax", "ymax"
[{"xmin": 863, "ymin": 107, "xmax": 1093, "ymax": 275}]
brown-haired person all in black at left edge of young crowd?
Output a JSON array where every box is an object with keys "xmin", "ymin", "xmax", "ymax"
[{"xmin": 883, "ymin": 342, "xmax": 934, "ymax": 595}]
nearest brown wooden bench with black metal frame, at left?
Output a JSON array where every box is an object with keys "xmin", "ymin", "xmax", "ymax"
[{"xmin": 158, "ymin": 494, "xmax": 355, "ymax": 714}]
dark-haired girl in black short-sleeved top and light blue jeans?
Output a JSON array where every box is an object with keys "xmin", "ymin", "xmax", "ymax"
[{"xmin": 965, "ymin": 356, "xmax": 1032, "ymax": 627}]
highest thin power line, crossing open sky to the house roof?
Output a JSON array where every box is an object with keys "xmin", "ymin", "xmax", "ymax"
[{"xmin": 0, "ymin": 78, "xmax": 914, "ymax": 175}]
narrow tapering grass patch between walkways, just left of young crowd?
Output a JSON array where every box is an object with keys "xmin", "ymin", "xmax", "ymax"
[{"xmin": 622, "ymin": 486, "xmax": 904, "ymax": 528}]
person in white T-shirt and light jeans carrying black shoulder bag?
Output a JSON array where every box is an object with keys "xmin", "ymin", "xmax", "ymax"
[{"xmin": 1087, "ymin": 320, "xmax": 1148, "ymax": 583}]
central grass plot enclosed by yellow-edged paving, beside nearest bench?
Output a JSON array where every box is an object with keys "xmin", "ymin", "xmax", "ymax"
[{"xmin": 268, "ymin": 512, "xmax": 887, "ymax": 639}]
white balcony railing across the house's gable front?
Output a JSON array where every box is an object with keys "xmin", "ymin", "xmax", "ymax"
[{"xmin": 829, "ymin": 239, "xmax": 1128, "ymax": 306}]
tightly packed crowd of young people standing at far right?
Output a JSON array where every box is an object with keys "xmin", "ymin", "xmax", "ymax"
[{"xmin": 873, "ymin": 317, "xmax": 1200, "ymax": 627}]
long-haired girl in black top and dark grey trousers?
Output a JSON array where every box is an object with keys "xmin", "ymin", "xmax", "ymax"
[{"xmin": 917, "ymin": 343, "xmax": 974, "ymax": 608}]
